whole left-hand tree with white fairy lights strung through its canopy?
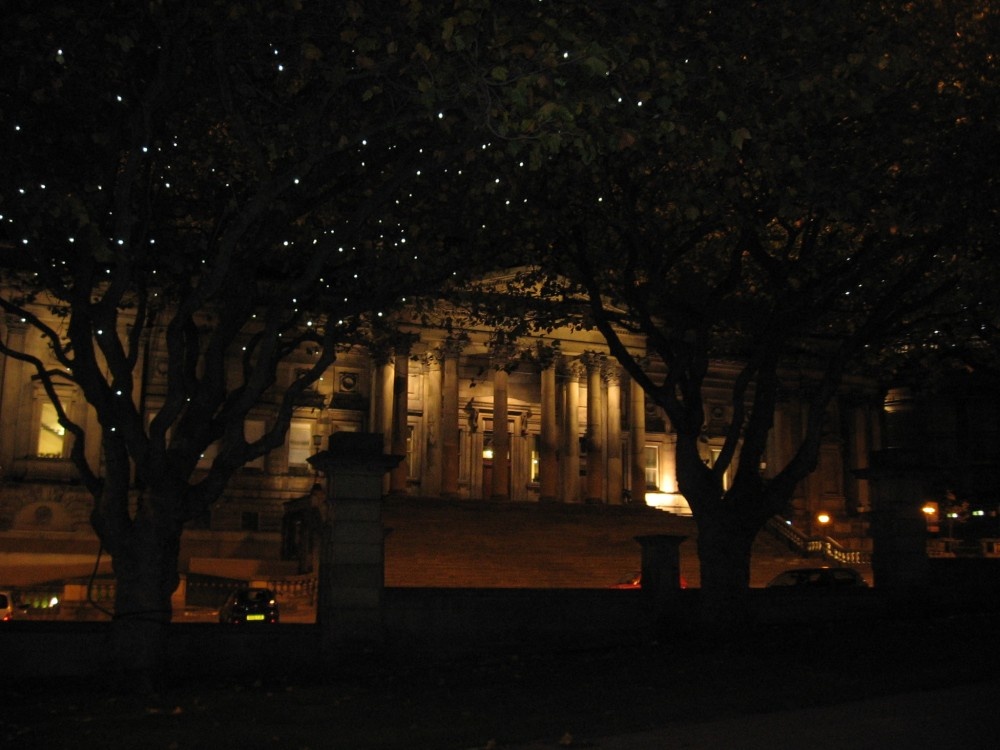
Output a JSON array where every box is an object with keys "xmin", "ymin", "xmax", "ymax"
[{"xmin": 0, "ymin": 0, "xmax": 552, "ymax": 665}]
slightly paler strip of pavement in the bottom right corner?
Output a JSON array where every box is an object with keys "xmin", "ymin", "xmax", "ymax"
[{"xmin": 504, "ymin": 678, "xmax": 1000, "ymax": 750}]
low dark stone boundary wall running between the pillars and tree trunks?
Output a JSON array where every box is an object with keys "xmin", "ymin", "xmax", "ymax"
[{"xmin": 7, "ymin": 572, "xmax": 1000, "ymax": 684}]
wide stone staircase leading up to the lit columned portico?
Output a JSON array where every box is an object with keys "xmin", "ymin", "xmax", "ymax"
[{"xmin": 383, "ymin": 498, "xmax": 840, "ymax": 588}]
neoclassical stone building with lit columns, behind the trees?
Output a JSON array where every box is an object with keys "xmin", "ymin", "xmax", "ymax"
[{"xmin": 0, "ymin": 298, "xmax": 881, "ymax": 544}]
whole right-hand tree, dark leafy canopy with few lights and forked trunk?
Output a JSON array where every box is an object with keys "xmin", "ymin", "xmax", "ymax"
[{"xmin": 450, "ymin": 1, "xmax": 1000, "ymax": 618}]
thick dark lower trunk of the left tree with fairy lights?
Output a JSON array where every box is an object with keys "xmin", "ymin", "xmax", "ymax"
[{"xmin": 95, "ymin": 488, "xmax": 182, "ymax": 691}]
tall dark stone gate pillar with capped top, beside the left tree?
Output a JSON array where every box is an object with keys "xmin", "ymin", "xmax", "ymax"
[{"xmin": 309, "ymin": 432, "xmax": 402, "ymax": 660}]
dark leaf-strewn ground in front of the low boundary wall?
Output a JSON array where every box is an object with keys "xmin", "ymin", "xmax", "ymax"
[{"xmin": 0, "ymin": 613, "xmax": 1000, "ymax": 750}]
